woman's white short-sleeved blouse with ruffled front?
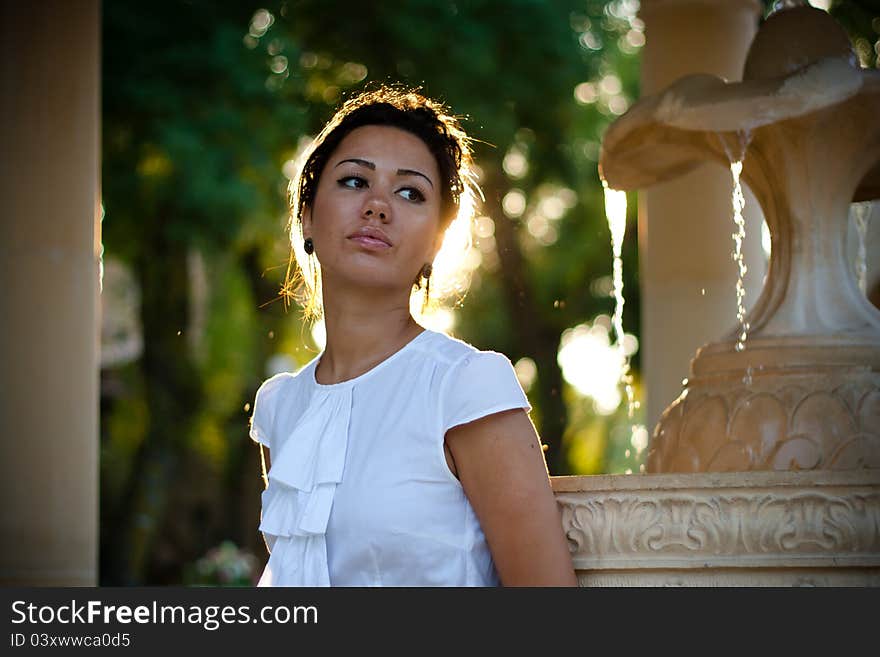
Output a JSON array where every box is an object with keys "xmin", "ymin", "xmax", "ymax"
[{"xmin": 250, "ymin": 330, "xmax": 531, "ymax": 586}]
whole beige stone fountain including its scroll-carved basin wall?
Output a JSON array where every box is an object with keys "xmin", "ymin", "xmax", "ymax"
[{"xmin": 554, "ymin": 3, "xmax": 880, "ymax": 585}]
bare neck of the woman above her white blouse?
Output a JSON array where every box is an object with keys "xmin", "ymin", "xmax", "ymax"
[{"xmin": 315, "ymin": 290, "xmax": 424, "ymax": 384}]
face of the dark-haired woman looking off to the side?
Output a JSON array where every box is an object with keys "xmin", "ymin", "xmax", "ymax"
[{"xmin": 303, "ymin": 125, "xmax": 442, "ymax": 295}]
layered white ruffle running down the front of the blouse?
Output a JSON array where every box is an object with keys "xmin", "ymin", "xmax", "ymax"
[{"xmin": 259, "ymin": 386, "xmax": 352, "ymax": 586}]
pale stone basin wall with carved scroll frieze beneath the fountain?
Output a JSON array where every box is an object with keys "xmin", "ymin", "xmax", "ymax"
[{"xmin": 553, "ymin": 470, "xmax": 880, "ymax": 586}]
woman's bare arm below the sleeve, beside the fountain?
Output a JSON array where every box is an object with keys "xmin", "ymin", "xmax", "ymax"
[{"xmin": 446, "ymin": 409, "xmax": 577, "ymax": 586}]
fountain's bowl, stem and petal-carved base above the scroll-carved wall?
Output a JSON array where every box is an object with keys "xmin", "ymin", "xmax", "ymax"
[{"xmin": 600, "ymin": 6, "xmax": 880, "ymax": 472}]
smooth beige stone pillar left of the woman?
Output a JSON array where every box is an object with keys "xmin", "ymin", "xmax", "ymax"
[{"xmin": 0, "ymin": 0, "xmax": 101, "ymax": 586}]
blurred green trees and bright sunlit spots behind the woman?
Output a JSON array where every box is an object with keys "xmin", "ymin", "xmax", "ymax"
[{"xmin": 99, "ymin": 0, "xmax": 880, "ymax": 586}]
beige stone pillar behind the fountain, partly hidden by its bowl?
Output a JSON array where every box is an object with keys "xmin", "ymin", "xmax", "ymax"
[{"xmin": 639, "ymin": 0, "xmax": 766, "ymax": 430}]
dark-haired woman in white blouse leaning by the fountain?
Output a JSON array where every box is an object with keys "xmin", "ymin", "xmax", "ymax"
[{"xmin": 251, "ymin": 88, "xmax": 576, "ymax": 586}]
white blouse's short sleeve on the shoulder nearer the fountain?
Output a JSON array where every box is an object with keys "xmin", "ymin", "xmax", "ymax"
[{"xmin": 440, "ymin": 351, "xmax": 532, "ymax": 434}]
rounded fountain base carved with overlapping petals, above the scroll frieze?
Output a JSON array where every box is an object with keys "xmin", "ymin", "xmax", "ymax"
[{"xmin": 646, "ymin": 340, "xmax": 880, "ymax": 472}]
